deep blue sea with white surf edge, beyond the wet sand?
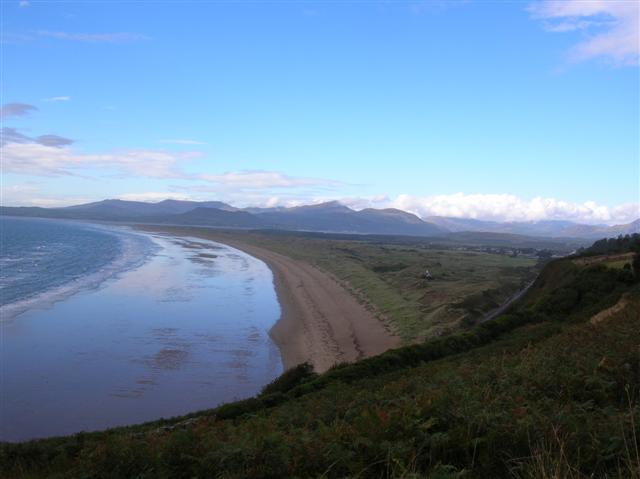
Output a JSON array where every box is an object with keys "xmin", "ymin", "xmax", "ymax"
[{"xmin": 0, "ymin": 216, "xmax": 155, "ymax": 321}]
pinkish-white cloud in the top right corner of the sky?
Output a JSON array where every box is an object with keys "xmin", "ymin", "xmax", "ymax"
[{"xmin": 529, "ymin": 0, "xmax": 640, "ymax": 65}]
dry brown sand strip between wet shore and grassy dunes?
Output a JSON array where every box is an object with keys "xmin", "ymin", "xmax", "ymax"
[{"xmin": 141, "ymin": 227, "xmax": 400, "ymax": 372}]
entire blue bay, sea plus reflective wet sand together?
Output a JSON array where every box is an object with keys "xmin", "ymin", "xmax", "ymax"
[{"xmin": 0, "ymin": 218, "xmax": 282, "ymax": 441}]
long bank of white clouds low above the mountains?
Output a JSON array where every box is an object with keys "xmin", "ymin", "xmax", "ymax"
[{"xmin": 0, "ymin": 96, "xmax": 640, "ymax": 224}]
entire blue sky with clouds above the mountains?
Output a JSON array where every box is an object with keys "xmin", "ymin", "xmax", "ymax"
[{"xmin": 0, "ymin": 0, "xmax": 640, "ymax": 224}]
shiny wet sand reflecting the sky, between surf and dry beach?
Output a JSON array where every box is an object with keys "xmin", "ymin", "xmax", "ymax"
[{"xmin": 0, "ymin": 235, "xmax": 282, "ymax": 440}]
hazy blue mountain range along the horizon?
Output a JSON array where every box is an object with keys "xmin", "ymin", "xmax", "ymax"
[{"xmin": 0, "ymin": 199, "xmax": 640, "ymax": 239}]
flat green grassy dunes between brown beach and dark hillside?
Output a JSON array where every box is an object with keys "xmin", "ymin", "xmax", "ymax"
[{"xmin": 151, "ymin": 228, "xmax": 537, "ymax": 342}]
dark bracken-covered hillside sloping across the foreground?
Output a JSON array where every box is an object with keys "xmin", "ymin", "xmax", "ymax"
[{"xmin": 0, "ymin": 244, "xmax": 640, "ymax": 479}]
